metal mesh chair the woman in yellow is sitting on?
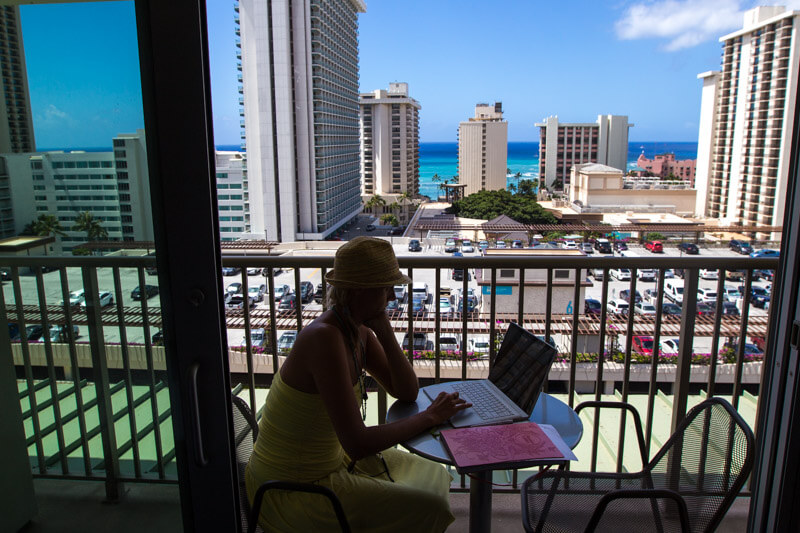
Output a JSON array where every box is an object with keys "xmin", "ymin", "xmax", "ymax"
[{"xmin": 231, "ymin": 395, "xmax": 350, "ymax": 533}]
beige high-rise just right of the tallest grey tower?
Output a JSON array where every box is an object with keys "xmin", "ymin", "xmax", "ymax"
[{"xmin": 359, "ymin": 83, "xmax": 421, "ymax": 223}]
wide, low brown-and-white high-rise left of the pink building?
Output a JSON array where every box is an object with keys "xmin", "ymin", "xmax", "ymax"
[{"xmin": 536, "ymin": 115, "xmax": 633, "ymax": 191}]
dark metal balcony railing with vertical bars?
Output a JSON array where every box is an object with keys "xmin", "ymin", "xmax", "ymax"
[{"xmin": 0, "ymin": 250, "xmax": 778, "ymax": 498}]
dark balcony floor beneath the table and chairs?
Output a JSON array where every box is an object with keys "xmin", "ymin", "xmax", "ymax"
[{"xmin": 21, "ymin": 479, "xmax": 750, "ymax": 533}]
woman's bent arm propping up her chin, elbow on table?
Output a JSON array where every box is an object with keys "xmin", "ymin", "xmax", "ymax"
[{"xmin": 364, "ymin": 313, "xmax": 419, "ymax": 402}]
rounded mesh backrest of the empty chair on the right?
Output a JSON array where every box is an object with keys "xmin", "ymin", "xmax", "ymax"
[{"xmin": 645, "ymin": 398, "xmax": 754, "ymax": 531}]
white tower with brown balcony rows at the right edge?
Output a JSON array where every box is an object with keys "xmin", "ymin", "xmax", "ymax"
[{"xmin": 695, "ymin": 7, "xmax": 800, "ymax": 238}]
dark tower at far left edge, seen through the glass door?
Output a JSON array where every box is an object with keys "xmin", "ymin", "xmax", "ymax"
[{"xmin": 0, "ymin": 6, "xmax": 36, "ymax": 154}]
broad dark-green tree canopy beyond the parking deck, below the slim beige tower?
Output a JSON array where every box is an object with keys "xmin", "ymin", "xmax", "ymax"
[{"xmin": 445, "ymin": 190, "xmax": 558, "ymax": 224}]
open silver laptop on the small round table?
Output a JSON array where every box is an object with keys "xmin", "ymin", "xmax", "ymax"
[{"xmin": 423, "ymin": 323, "xmax": 556, "ymax": 428}]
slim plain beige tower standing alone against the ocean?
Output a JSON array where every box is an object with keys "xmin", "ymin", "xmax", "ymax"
[{"xmin": 458, "ymin": 102, "xmax": 508, "ymax": 196}]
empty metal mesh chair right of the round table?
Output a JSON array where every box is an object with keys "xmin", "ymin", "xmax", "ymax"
[{"xmin": 522, "ymin": 398, "xmax": 753, "ymax": 533}]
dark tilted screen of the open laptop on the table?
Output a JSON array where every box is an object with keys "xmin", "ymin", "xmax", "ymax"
[{"xmin": 489, "ymin": 322, "xmax": 556, "ymax": 415}]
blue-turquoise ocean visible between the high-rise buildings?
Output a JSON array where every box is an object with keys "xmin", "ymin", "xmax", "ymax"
[{"xmin": 217, "ymin": 142, "xmax": 697, "ymax": 198}]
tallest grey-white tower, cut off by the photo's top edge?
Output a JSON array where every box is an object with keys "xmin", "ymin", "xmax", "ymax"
[{"xmin": 236, "ymin": 0, "xmax": 366, "ymax": 241}]
